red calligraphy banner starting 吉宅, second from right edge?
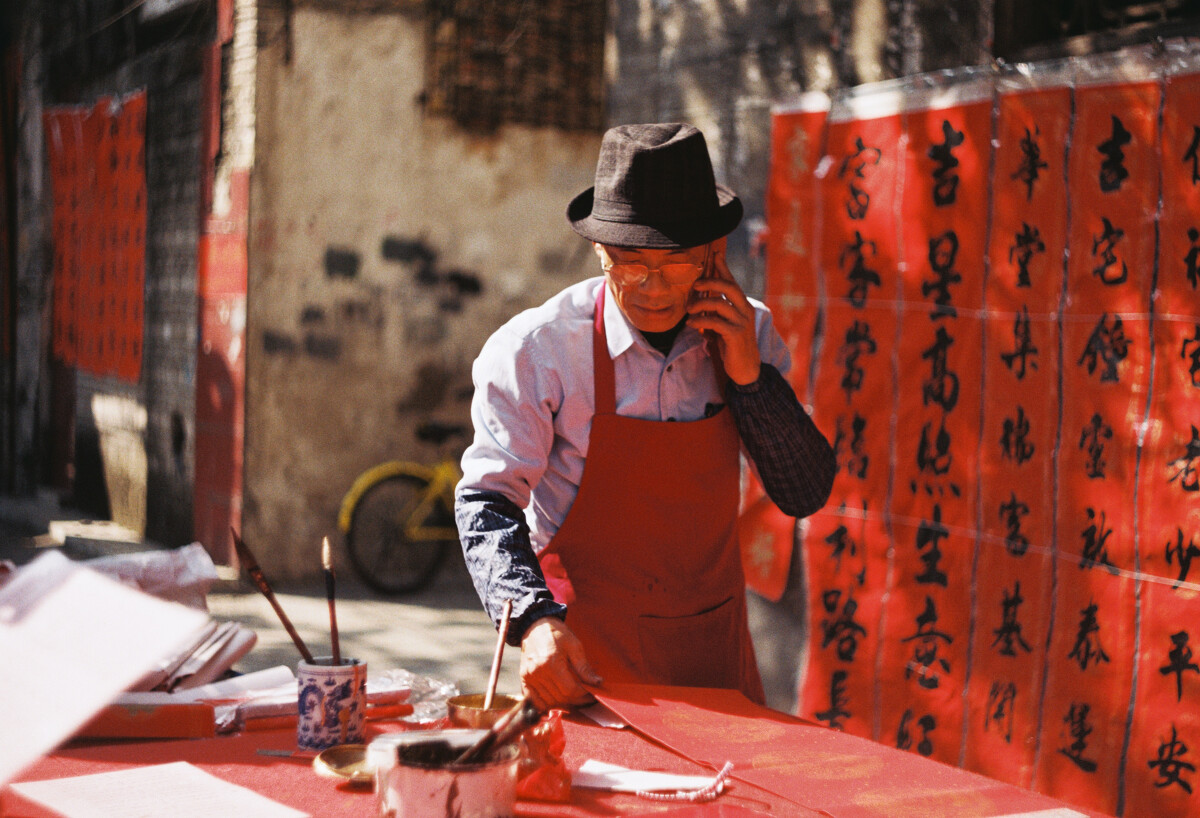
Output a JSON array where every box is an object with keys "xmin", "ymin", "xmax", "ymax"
[{"xmin": 1037, "ymin": 72, "xmax": 1159, "ymax": 812}]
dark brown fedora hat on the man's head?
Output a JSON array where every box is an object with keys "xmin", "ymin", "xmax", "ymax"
[{"xmin": 566, "ymin": 122, "xmax": 742, "ymax": 248}]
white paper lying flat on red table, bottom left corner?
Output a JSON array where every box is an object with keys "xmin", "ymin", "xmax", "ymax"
[{"xmin": 11, "ymin": 762, "xmax": 308, "ymax": 818}]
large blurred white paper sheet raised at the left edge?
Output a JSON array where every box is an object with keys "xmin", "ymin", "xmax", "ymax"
[{"xmin": 0, "ymin": 552, "xmax": 208, "ymax": 784}]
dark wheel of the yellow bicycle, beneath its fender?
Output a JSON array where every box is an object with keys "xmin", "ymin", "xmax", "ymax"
[{"xmin": 346, "ymin": 474, "xmax": 457, "ymax": 594}]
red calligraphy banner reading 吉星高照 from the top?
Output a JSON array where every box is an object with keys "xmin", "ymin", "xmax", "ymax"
[{"xmin": 881, "ymin": 87, "xmax": 992, "ymax": 764}]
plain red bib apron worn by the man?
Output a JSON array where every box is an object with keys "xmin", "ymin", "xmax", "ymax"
[{"xmin": 539, "ymin": 285, "xmax": 764, "ymax": 704}]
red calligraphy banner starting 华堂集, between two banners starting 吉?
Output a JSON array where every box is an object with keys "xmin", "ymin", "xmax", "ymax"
[{"xmin": 964, "ymin": 78, "xmax": 1070, "ymax": 787}]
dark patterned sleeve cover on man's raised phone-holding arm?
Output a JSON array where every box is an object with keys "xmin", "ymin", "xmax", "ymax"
[{"xmin": 727, "ymin": 363, "xmax": 838, "ymax": 517}]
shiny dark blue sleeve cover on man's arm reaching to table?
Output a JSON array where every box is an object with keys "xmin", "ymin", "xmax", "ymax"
[{"xmin": 455, "ymin": 491, "xmax": 566, "ymax": 646}]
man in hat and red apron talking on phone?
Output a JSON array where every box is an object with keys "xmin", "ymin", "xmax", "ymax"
[{"xmin": 455, "ymin": 124, "xmax": 835, "ymax": 710}]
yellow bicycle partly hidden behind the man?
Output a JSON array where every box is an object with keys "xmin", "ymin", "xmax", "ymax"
[{"xmin": 337, "ymin": 423, "xmax": 467, "ymax": 594}]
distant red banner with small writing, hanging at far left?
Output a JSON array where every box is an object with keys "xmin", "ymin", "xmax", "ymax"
[{"xmin": 44, "ymin": 92, "xmax": 146, "ymax": 381}]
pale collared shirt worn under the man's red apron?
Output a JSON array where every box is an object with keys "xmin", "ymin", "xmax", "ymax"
[{"xmin": 458, "ymin": 276, "xmax": 791, "ymax": 552}]
